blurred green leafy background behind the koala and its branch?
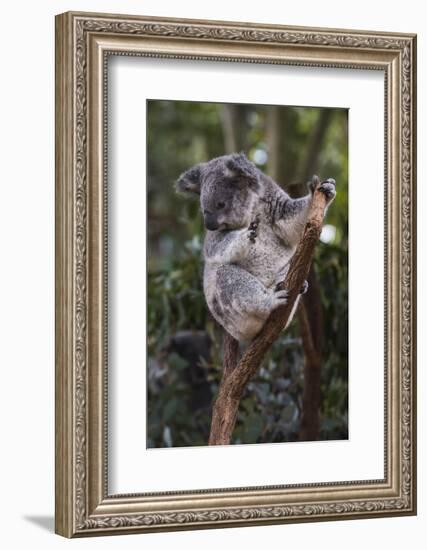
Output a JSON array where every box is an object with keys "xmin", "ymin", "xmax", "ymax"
[{"xmin": 147, "ymin": 100, "xmax": 348, "ymax": 447}]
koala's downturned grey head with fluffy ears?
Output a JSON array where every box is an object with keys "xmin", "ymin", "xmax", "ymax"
[{"xmin": 176, "ymin": 153, "xmax": 261, "ymax": 231}]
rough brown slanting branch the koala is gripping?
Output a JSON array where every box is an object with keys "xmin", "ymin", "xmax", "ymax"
[{"xmin": 209, "ymin": 179, "xmax": 326, "ymax": 445}]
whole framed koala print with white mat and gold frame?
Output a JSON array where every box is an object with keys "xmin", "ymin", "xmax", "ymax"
[{"xmin": 56, "ymin": 12, "xmax": 416, "ymax": 537}]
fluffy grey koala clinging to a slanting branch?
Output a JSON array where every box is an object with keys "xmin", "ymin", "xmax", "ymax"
[{"xmin": 176, "ymin": 153, "xmax": 336, "ymax": 342}]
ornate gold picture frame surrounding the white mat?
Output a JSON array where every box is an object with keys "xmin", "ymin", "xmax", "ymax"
[{"xmin": 55, "ymin": 13, "xmax": 416, "ymax": 537}]
